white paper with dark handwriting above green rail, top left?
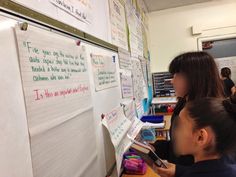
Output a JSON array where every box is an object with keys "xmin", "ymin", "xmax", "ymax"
[{"xmin": 10, "ymin": 0, "xmax": 109, "ymax": 41}]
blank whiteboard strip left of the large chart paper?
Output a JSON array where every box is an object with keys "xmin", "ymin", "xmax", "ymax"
[{"xmin": 0, "ymin": 15, "xmax": 33, "ymax": 177}]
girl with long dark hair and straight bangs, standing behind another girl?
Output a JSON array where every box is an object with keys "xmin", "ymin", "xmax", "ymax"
[{"xmin": 154, "ymin": 52, "xmax": 224, "ymax": 166}]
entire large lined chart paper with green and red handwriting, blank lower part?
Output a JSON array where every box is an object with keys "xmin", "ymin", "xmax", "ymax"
[{"xmin": 15, "ymin": 26, "xmax": 97, "ymax": 177}]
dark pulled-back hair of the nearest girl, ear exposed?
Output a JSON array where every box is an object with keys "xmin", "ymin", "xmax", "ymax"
[{"xmin": 186, "ymin": 95, "xmax": 236, "ymax": 155}]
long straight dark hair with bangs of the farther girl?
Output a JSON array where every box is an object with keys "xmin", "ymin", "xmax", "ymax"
[{"xmin": 169, "ymin": 52, "xmax": 224, "ymax": 101}]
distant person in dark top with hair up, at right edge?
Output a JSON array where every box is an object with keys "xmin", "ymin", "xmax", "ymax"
[{"xmin": 220, "ymin": 67, "xmax": 236, "ymax": 97}]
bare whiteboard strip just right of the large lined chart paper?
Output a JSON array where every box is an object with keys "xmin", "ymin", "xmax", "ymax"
[{"xmin": 82, "ymin": 40, "xmax": 122, "ymax": 176}]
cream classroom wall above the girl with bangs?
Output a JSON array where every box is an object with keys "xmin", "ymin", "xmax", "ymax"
[{"xmin": 148, "ymin": 0, "xmax": 236, "ymax": 72}]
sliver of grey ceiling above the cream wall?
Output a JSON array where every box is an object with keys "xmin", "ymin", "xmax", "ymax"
[{"xmin": 143, "ymin": 0, "xmax": 215, "ymax": 12}]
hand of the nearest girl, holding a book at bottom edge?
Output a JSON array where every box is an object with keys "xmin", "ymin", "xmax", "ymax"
[{"xmin": 156, "ymin": 162, "xmax": 176, "ymax": 177}]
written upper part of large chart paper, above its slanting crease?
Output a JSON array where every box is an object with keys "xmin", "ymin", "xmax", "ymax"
[{"xmin": 16, "ymin": 25, "xmax": 92, "ymax": 132}]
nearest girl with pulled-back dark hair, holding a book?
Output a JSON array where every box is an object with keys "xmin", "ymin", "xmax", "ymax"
[{"xmin": 157, "ymin": 97, "xmax": 236, "ymax": 177}]
